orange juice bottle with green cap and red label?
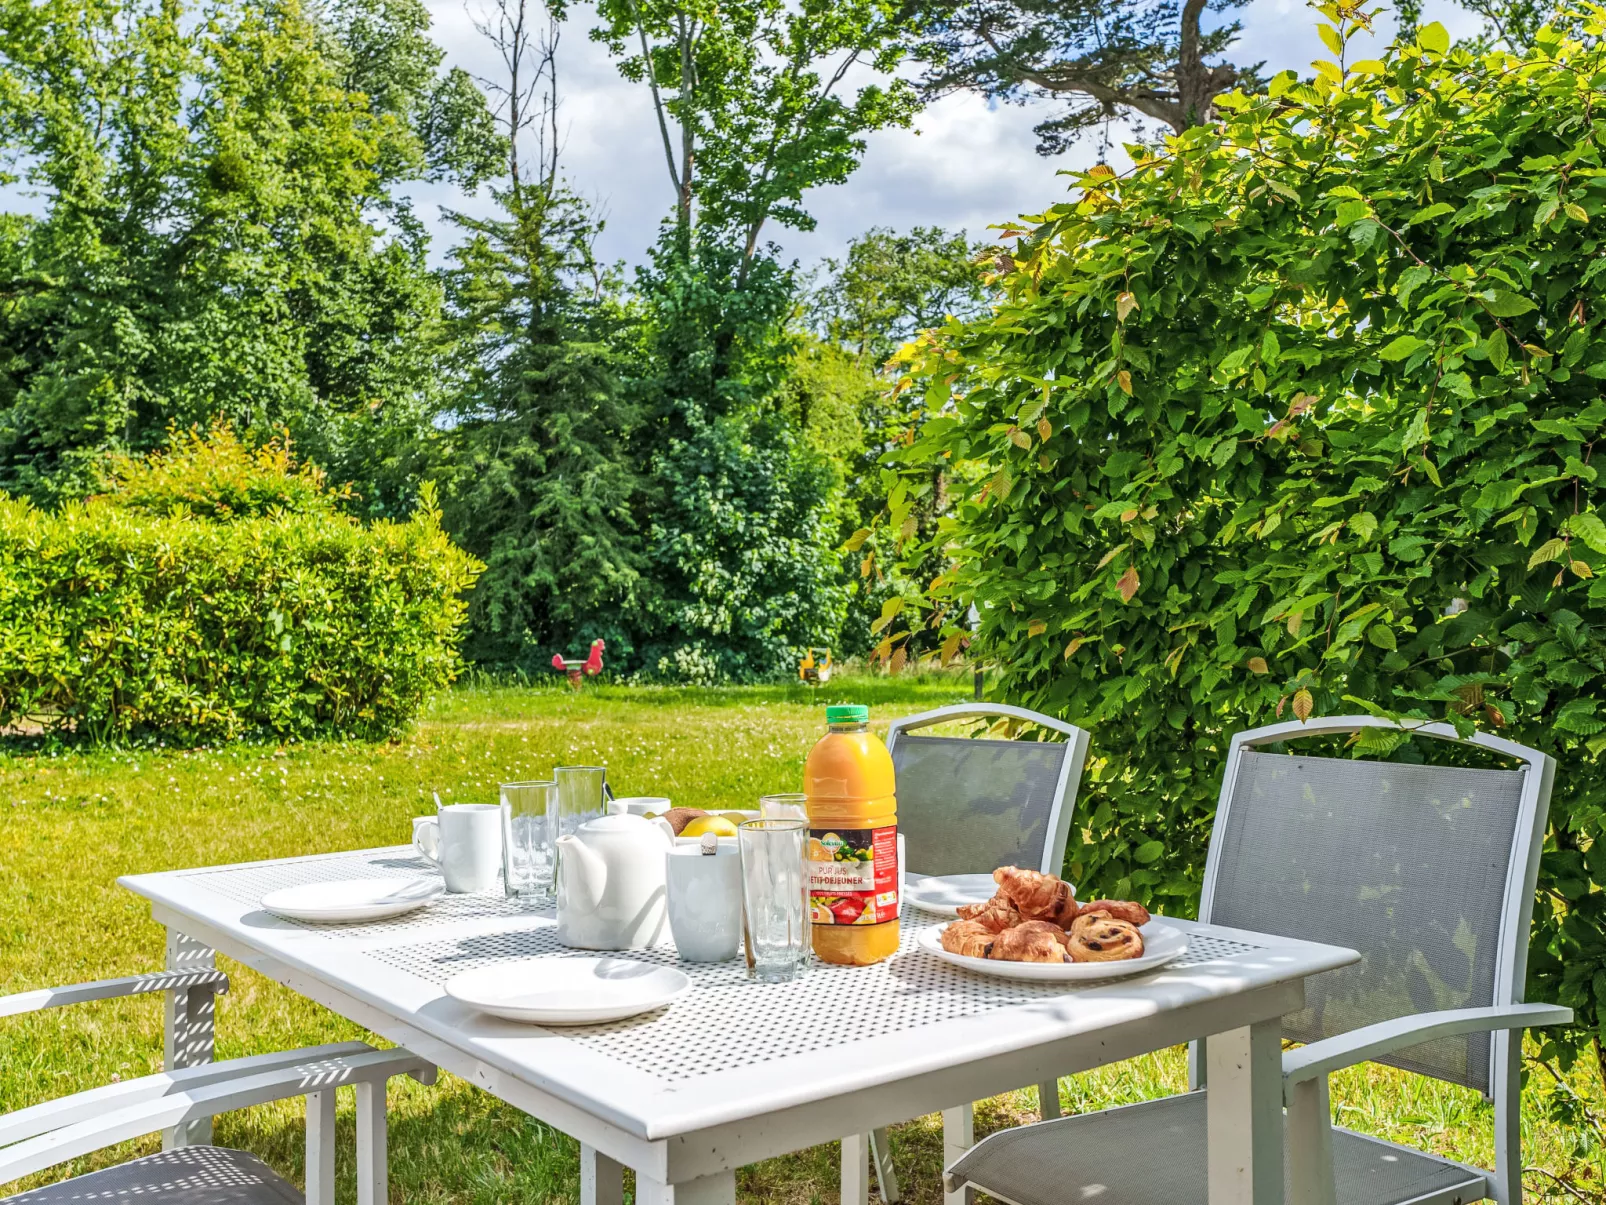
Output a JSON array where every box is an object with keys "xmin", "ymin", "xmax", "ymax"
[{"xmin": 803, "ymin": 707, "xmax": 899, "ymax": 967}]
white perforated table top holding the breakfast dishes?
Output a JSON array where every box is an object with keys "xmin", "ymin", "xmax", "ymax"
[{"xmin": 124, "ymin": 847, "xmax": 1351, "ymax": 1138}]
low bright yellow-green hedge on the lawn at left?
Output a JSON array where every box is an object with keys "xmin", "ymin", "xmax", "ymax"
[{"xmin": 0, "ymin": 432, "xmax": 479, "ymax": 742}]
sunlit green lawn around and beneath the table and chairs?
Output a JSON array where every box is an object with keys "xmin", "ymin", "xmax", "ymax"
[{"xmin": 0, "ymin": 678, "xmax": 1606, "ymax": 1205}]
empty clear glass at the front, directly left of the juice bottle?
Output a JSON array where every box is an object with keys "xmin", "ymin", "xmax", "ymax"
[{"xmin": 736, "ymin": 819, "xmax": 809, "ymax": 983}]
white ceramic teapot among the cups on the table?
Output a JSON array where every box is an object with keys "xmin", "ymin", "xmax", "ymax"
[{"xmin": 556, "ymin": 813, "xmax": 675, "ymax": 950}]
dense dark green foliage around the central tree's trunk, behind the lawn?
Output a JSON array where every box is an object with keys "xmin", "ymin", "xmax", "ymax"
[{"xmin": 634, "ymin": 236, "xmax": 846, "ymax": 681}]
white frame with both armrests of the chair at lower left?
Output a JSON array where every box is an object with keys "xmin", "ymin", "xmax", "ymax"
[{"xmin": 0, "ymin": 969, "xmax": 437, "ymax": 1205}]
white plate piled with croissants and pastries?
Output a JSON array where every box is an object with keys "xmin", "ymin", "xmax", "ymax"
[{"xmin": 917, "ymin": 866, "xmax": 1188, "ymax": 982}]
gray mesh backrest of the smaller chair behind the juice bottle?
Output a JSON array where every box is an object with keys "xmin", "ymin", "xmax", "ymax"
[{"xmin": 887, "ymin": 702, "xmax": 1087, "ymax": 874}]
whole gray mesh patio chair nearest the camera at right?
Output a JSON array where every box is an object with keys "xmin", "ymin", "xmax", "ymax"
[{"xmin": 944, "ymin": 717, "xmax": 1572, "ymax": 1205}]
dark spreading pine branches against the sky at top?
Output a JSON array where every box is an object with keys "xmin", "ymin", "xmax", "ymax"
[{"xmin": 917, "ymin": 0, "xmax": 1259, "ymax": 154}]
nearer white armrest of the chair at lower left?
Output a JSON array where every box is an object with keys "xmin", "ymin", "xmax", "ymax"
[{"xmin": 0, "ymin": 1049, "xmax": 435, "ymax": 1184}]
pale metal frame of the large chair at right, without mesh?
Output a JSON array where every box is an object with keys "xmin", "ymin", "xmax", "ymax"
[{"xmin": 1188, "ymin": 715, "xmax": 1572, "ymax": 1205}]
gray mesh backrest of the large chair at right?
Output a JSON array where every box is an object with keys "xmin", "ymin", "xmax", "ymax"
[{"xmin": 1200, "ymin": 717, "xmax": 1555, "ymax": 1096}]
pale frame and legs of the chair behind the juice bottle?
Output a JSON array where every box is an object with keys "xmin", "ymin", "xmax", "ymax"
[{"xmin": 842, "ymin": 702, "xmax": 1092, "ymax": 1205}]
